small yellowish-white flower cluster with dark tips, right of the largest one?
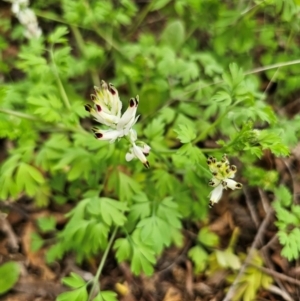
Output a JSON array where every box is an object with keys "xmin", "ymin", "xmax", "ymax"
[{"xmin": 207, "ymin": 155, "xmax": 243, "ymax": 208}]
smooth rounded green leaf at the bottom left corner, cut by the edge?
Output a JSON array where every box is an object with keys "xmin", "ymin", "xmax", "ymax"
[{"xmin": 0, "ymin": 261, "xmax": 21, "ymax": 295}]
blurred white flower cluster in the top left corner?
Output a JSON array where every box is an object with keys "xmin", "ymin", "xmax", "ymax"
[{"xmin": 11, "ymin": 0, "xmax": 42, "ymax": 39}]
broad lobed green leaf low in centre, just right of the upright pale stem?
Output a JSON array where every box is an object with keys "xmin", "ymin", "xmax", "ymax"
[{"xmin": 114, "ymin": 193, "xmax": 182, "ymax": 275}]
